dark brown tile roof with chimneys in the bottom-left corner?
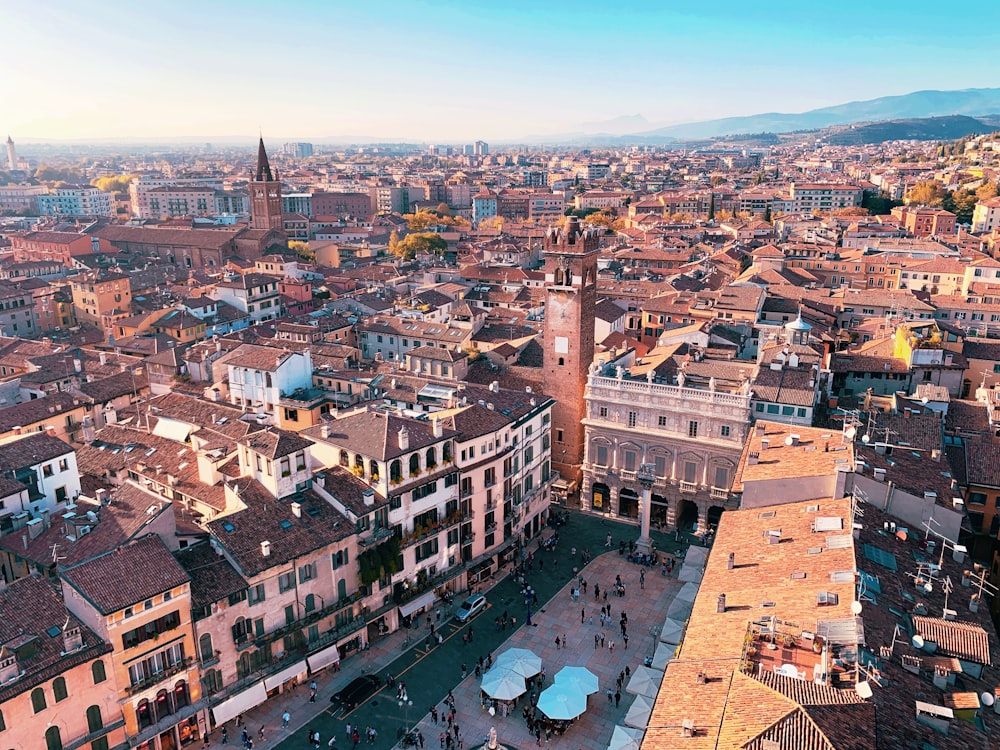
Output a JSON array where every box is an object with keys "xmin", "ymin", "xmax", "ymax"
[{"xmin": 0, "ymin": 576, "xmax": 112, "ymax": 704}]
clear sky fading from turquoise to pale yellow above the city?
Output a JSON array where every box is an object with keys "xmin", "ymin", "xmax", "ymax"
[{"xmin": 0, "ymin": 0, "xmax": 1000, "ymax": 143}]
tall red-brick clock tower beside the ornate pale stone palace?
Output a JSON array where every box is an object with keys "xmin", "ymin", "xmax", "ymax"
[{"xmin": 542, "ymin": 216, "xmax": 600, "ymax": 488}]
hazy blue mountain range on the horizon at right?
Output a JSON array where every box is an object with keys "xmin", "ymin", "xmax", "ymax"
[{"xmin": 625, "ymin": 88, "xmax": 1000, "ymax": 142}]
